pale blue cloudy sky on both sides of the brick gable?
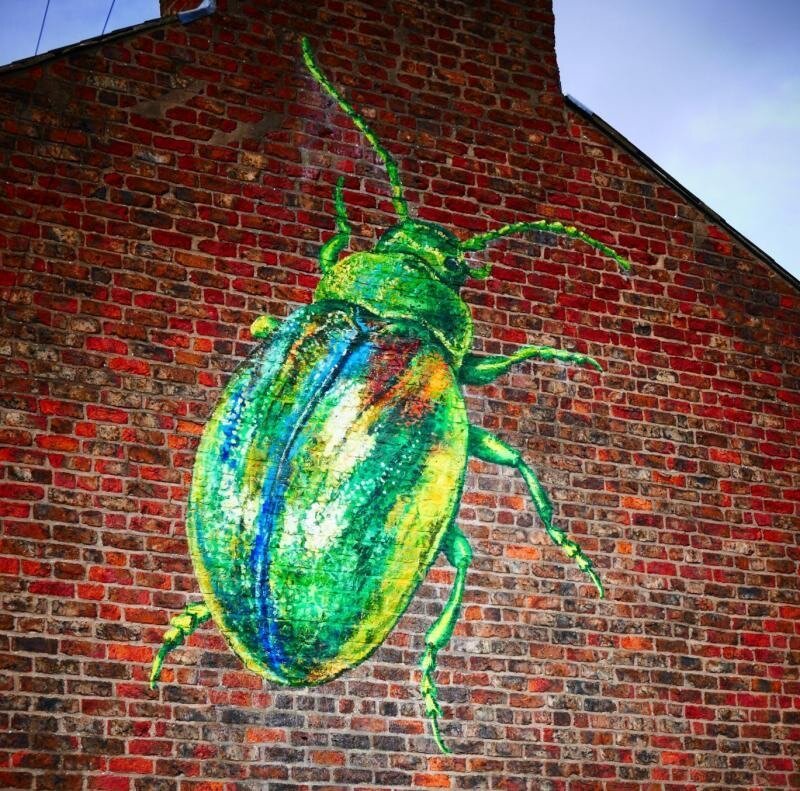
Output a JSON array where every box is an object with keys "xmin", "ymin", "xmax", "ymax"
[{"xmin": 0, "ymin": 0, "xmax": 800, "ymax": 277}]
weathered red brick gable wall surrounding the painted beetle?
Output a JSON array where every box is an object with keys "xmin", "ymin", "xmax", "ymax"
[{"xmin": 0, "ymin": 0, "xmax": 800, "ymax": 791}]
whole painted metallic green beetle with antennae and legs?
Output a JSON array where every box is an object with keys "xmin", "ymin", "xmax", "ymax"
[{"xmin": 150, "ymin": 39, "xmax": 630, "ymax": 752}]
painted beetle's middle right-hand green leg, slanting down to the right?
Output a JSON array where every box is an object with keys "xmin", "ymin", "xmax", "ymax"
[{"xmin": 468, "ymin": 426, "xmax": 605, "ymax": 597}]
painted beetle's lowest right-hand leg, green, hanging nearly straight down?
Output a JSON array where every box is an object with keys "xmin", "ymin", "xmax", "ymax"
[{"xmin": 420, "ymin": 524, "xmax": 472, "ymax": 753}]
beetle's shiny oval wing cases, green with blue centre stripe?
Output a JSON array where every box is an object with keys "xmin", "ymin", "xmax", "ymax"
[{"xmin": 189, "ymin": 303, "xmax": 467, "ymax": 684}]
